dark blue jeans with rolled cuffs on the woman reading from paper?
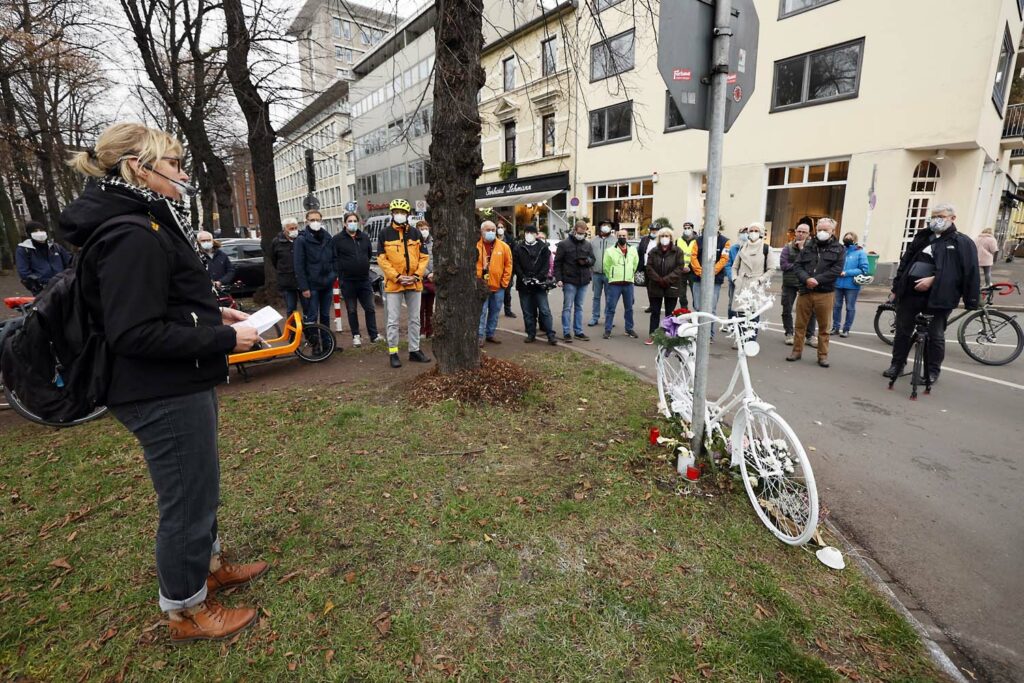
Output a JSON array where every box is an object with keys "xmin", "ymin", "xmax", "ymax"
[{"xmin": 111, "ymin": 389, "xmax": 220, "ymax": 611}]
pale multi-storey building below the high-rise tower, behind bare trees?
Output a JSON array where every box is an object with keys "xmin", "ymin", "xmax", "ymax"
[{"xmin": 273, "ymin": 81, "xmax": 354, "ymax": 233}]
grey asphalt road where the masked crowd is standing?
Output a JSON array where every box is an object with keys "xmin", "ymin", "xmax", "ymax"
[{"xmin": 501, "ymin": 278, "xmax": 1024, "ymax": 681}]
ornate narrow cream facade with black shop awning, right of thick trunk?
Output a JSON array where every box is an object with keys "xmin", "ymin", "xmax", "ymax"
[{"xmin": 476, "ymin": 0, "xmax": 580, "ymax": 237}]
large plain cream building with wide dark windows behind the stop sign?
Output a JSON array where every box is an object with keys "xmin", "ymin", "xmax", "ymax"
[{"xmin": 571, "ymin": 0, "xmax": 1024, "ymax": 261}]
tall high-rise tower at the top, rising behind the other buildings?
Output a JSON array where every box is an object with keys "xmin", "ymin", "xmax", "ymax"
[{"xmin": 287, "ymin": 0, "xmax": 399, "ymax": 103}]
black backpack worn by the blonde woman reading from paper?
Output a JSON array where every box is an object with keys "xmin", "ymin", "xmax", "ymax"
[{"xmin": 0, "ymin": 215, "xmax": 151, "ymax": 424}]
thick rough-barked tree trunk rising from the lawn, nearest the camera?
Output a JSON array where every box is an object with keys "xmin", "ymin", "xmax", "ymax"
[{"xmin": 427, "ymin": 0, "xmax": 487, "ymax": 375}]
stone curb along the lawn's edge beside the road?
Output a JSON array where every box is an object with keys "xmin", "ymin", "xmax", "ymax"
[{"xmin": 498, "ymin": 325, "xmax": 974, "ymax": 683}]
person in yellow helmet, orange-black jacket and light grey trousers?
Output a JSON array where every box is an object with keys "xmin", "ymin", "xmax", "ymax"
[{"xmin": 377, "ymin": 200, "xmax": 430, "ymax": 368}]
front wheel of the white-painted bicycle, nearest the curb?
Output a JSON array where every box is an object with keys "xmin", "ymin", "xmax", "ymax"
[{"xmin": 739, "ymin": 407, "xmax": 818, "ymax": 546}]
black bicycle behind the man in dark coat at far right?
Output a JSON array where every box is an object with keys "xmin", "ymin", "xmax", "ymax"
[{"xmin": 874, "ymin": 283, "xmax": 1024, "ymax": 366}]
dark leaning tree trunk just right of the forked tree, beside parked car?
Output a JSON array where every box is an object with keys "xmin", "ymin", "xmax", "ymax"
[{"xmin": 223, "ymin": 0, "xmax": 281, "ymax": 303}]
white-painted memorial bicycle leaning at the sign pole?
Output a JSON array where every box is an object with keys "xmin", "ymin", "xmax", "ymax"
[{"xmin": 656, "ymin": 299, "xmax": 818, "ymax": 546}]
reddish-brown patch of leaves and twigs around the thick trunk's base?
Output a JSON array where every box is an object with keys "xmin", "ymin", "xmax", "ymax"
[{"xmin": 410, "ymin": 355, "xmax": 539, "ymax": 405}]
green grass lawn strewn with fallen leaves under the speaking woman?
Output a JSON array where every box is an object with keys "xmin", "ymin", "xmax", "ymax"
[{"xmin": 0, "ymin": 353, "xmax": 942, "ymax": 681}]
